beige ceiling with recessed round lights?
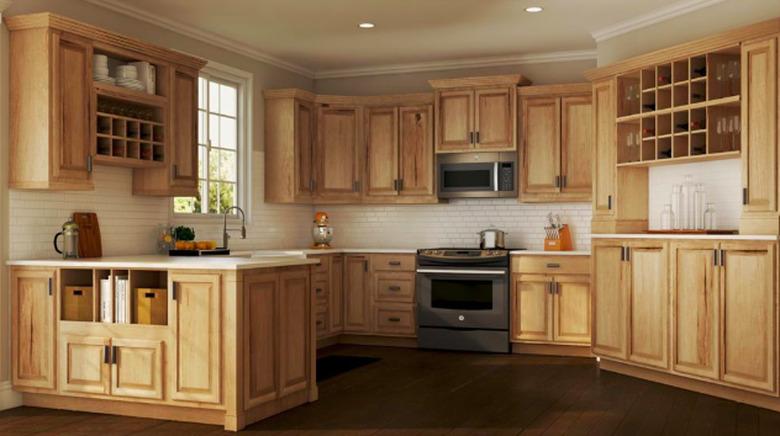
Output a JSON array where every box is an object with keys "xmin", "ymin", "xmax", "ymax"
[{"xmin": 87, "ymin": 0, "xmax": 712, "ymax": 76}]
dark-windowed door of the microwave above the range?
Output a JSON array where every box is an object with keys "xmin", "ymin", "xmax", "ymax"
[{"xmin": 439, "ymin": 162, "xmax": 498, "ymax": 198}]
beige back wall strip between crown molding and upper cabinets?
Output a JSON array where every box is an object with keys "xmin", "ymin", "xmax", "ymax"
[{"xmin": 314, "ymin": 59, "xmax": 596, "ymax": 95}]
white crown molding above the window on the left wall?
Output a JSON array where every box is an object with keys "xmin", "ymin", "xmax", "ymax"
[{"xmin": 84, "ymin": 0, "xmax": 314, "ymax": 79}]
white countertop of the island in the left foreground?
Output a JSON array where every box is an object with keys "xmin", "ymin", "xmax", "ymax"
[{"xmin": 7, "ymin": 254, "xmax": 320, "ymax": 270}]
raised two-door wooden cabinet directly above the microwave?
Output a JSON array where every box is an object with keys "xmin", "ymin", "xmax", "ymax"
[{"xmin": 429, "ymin": 75, "xmax": 531, "ymax": 153}]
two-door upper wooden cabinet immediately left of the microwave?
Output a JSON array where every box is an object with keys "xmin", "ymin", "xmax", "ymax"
[{"xmin": 364, "ymin": 105, "xmax": 436, "ymax": 202}]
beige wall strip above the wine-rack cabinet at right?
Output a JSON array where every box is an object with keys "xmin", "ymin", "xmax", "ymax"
[{"xmin": 596, "ymin": 0, "xmax": 780, "ymax": 66}]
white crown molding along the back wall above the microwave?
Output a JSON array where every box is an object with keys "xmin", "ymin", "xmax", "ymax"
[{"xmin": 314, "ymin": 50, "xmax": 596, "ymax": 79}]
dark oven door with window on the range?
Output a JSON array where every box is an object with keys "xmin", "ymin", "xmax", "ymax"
[{"xmin": 417, "ymin": 267, "xmax": 509, "ymax": 330}]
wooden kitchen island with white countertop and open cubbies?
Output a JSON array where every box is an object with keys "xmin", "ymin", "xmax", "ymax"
[{"xmin": 8, "ymin": 255, "xmax": 319, "ymax": 431}]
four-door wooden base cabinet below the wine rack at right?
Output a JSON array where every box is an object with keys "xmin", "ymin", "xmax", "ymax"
[{"xmin": 593, "ymin": 239, "xmax": 778, "ymax": 396}]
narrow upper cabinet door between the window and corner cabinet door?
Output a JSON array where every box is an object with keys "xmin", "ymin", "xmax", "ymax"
[{"xmin": 295, "ymin": 100, "xmax": 316, "ymax": 201}]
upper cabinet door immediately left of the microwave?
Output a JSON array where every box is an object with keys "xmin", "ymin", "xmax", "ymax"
[{"xmin": 398, "ymin": 105, "xmax": 434, "ymax": 195}]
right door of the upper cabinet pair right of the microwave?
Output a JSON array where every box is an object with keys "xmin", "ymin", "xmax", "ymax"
[{"xmin": 561, "ymin": 95, "xmax": 593, "ymax": 199}]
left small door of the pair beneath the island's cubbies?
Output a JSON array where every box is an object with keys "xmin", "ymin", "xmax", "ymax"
[{"xmin": 58, "ymin": 335, "xmax": 111, "ymax": 395}]
